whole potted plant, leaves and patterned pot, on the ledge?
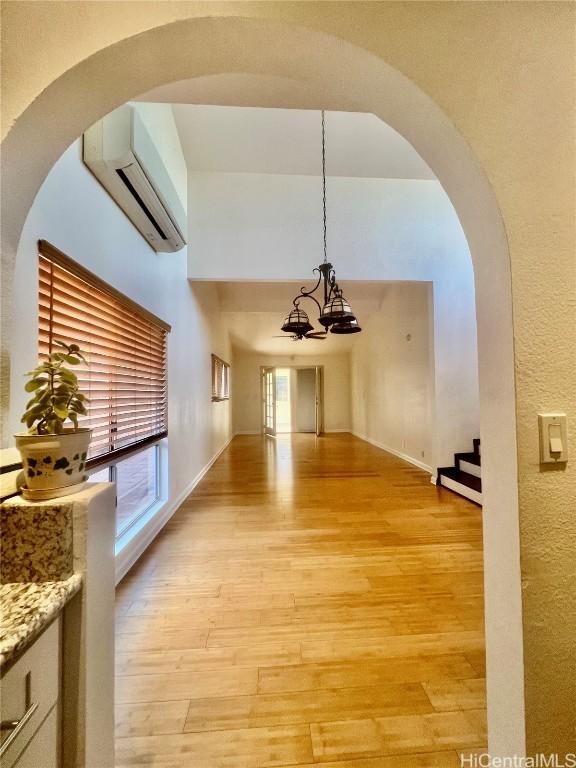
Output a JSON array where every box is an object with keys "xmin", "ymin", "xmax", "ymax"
[{"xmin": 15, "ymin": 341, "xmax": 92, "ymax": 499}]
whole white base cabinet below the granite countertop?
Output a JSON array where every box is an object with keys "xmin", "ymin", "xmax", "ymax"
[{"xmin": 0, "ymin": 618, "xmax": 61, "ymax": 768}]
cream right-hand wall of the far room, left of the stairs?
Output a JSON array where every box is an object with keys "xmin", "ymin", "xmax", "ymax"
[{"xmin": 350, "ymin": 283, "xmax": 432, "ymax": 466}]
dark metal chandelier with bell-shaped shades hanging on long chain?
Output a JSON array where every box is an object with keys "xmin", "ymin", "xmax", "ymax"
[{"xmin": 282, "ymin": 110, "xmax": 362, "ymax": 340}]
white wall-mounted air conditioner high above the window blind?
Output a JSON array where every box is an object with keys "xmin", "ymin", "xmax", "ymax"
[{"xmin": 83, "ymin": 105, "xmax": 186, "ymax": 251}]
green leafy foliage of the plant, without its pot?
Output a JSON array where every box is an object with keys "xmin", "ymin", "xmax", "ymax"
[{"xmin": 21, "ymin": 341, "xmax": 88, "ymax": 435}]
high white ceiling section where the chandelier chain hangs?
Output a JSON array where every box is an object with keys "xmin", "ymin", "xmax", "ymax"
[{"xmin": 172, "ymin": 104, "xmax": 435, "ymax": 179}]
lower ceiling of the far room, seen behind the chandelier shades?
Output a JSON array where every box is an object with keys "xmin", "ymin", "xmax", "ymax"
[{"xmin": 214, "ymin": 280, "xmax": 420, "ymax": 356}]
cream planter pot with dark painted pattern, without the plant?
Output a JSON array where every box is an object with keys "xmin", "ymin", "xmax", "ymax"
[{"xmin": 14, "ymin": 429, "xmax": 92, "ymax": 491}]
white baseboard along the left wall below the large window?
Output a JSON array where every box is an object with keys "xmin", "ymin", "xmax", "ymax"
[{"xmin": 115, "ymin": 434, "xmax": 235, "ymax": 584}]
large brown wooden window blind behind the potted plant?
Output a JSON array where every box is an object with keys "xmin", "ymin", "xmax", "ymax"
[{"xmin": 39, "ymin": 240, "xmax": 170, "ymax": 466}]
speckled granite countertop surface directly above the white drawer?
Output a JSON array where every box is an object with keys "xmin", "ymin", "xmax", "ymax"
[{"xmin": 0, "ymin": 573, "xmax": 82, "ymax": 666}]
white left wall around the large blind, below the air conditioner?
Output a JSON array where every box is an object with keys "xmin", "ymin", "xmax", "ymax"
[{"xmin": 11, "ymin": 134, "xmax": 231, "ymax": 520}]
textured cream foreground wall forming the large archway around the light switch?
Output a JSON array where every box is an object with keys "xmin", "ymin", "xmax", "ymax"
[{"xmin": 2, "ymin": 2, "xmax": 576, "ymax": 755}]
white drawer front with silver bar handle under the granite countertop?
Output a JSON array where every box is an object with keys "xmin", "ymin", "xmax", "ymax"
[{"xmin": 0, "ymin": 618, "xmax": 60, "ymax": 768}]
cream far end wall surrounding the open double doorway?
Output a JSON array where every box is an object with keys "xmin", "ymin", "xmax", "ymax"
[{"xmin": 232, "ymin": 352, "xmax": 351, "ymax": 432}]
